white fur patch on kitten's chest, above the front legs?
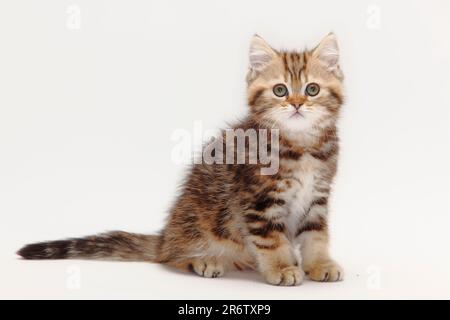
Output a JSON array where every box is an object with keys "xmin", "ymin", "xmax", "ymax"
[{"xmin": 282, "ymin": 154, "xmax": 323, "ymax": 234}]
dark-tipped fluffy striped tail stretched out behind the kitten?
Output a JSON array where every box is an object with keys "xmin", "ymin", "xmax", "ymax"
[{"xmin": 17, "ymin": 231, "xmax": 161, "ymax": 262}]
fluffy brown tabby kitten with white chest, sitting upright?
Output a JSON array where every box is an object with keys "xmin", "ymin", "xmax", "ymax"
[{"xmin": 18, "ymin": 34, "xmax": 343, "ymax": 286}]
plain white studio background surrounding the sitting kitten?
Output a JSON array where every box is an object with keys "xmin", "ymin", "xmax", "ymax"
[{"xmin": 0, "ymin": 0, "xmax": 450, "ymax": 299}]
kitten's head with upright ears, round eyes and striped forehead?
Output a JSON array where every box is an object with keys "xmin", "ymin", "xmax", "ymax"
[{"xmin": 247, "ymin": 34, "xmax": 343, "ymax": 134}]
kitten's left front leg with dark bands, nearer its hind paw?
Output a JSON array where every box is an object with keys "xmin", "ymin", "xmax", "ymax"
[{"xmin": 245, "ymin": 213, "xmax": 304, "ymax": 286}]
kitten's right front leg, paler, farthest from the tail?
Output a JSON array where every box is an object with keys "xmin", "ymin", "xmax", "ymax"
[{"xmin": 296, "ymin": 201, "xmax": 344, "ymax": 282}]
